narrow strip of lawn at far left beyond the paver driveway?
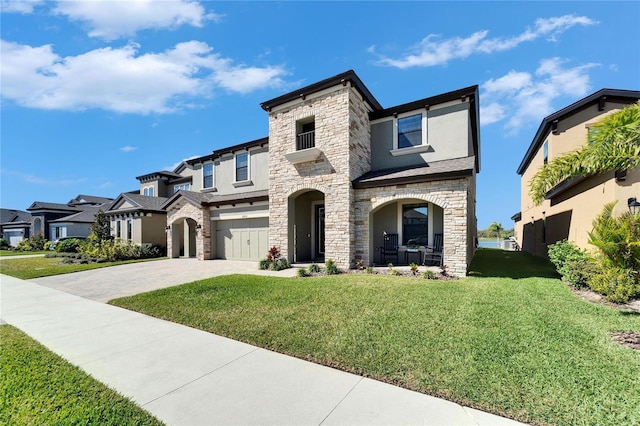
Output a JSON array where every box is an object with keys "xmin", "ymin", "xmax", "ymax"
[{"xmin": 0, "ymin": 257, "xmax": 165, "ymax": 280}]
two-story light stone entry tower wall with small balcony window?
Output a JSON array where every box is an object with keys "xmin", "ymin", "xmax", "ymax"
[{"xmin": 269, "ymin": 83, "xmax": 371, "ymax": 268}]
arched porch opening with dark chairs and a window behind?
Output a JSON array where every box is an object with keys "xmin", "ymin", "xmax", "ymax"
[{"xmin": 369, "ymin": 198, "xmax": 446, "ymax": 265}]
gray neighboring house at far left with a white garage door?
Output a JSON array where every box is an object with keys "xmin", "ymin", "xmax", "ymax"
[{"xmin": 27, "ymin": 195, "xmax": 113, "ymax": 241}]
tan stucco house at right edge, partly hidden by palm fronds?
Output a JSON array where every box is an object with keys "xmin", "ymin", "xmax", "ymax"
[{"xmin": 512, "ymin": 89, "xmax": 640, "ymax": 256}]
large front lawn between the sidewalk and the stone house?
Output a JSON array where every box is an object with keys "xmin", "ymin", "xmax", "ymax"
[{"xmin": 110, "ymin": 249, "xmax": 640, "ymax": 425}]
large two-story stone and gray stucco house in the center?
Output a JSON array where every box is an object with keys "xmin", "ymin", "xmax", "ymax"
[{"xmin": 152, "ymin": 71, "xmax": 480, "ymax": 276}]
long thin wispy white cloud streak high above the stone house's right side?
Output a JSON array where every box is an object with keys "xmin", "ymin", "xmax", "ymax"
[{"xmin": 368, "ymin": 15, "xmax": 597, "ymax": 69}]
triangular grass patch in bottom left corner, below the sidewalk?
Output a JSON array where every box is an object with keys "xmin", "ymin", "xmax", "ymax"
[{"xmin": 0, "ymin": 325, "xmax": 163, "ymax": 425}]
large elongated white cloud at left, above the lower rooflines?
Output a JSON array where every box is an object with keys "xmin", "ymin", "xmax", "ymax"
[{"xmin": 0, "ymin": 40, "xmax": 287, "ymax": 114}]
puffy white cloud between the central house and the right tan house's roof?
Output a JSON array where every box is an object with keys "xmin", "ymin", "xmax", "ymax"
[{"xmin": 480, "ymin": 58, "xmax": 597, "ymax": 134}]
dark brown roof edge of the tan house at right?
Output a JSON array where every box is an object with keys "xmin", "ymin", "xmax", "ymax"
[{"xmin": 517, "ymin": 89, "xmax": 640, "ymax": 175}]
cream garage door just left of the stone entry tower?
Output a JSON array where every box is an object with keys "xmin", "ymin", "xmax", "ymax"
[{"xmin": 216, "ymin": 217, "xmax": 269, "ymax": 261}]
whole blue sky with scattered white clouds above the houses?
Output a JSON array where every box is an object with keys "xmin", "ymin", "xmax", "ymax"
[{"xmin": 0, "ymin": 0, "xmax": 640, "ymax": 229}]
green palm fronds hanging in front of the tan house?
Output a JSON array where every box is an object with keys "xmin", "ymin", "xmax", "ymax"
[{"xmin": 529, "ymin": 101, "xmax": 640, "ymax": 205}]
